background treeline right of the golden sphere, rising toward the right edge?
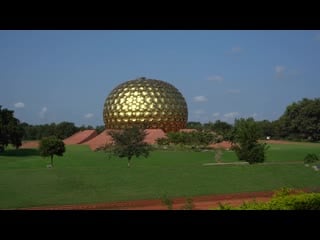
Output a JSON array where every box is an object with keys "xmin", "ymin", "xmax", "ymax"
[{"xmin": 187, "ymin": 98, "xmax": 320, "ymax": 142}]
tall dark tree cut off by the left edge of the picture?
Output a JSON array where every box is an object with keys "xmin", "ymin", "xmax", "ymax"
[{"xmin": 0, "ymin": 105, "xmax": 23, "ymax": 152}]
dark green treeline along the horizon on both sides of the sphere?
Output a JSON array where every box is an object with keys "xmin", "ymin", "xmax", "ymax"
[{"xmin": 0, "ymin": 98, "xmax": 320, "ymax": 146}]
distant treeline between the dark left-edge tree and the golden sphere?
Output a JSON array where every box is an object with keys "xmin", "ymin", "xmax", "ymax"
[{"xmin": 21, "ymin": 122, "xmax": 104, "ymax": 140}]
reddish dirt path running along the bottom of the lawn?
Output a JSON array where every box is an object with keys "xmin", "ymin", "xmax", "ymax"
[{"xmin": 23, "ymin": 192, "xmax": 273, "ymax": 210}]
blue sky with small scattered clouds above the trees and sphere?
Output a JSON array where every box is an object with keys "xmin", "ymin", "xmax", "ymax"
[{"xmin": 0, "ymin": 30, "xmax": 320, "ymax": 126}]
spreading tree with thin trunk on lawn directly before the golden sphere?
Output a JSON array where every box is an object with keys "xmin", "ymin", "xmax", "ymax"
[{"xmin": 109, "ymin": 127, "xmax": 151, "ymax": 167}]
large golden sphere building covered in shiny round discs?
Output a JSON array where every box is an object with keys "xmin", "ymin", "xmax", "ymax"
[{"xmin": 103, "ymin": 78, "xmax": 188, "ymax": 132}]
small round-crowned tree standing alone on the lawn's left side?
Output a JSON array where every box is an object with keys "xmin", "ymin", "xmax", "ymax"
[{"xmin": 39, "ymin": 136, "xmax": 66, "ymax": 167}]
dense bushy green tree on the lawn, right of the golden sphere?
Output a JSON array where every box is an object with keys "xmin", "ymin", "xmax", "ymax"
[{"xmin": 232, "ymin": 118, "xmax": 267, "ymax": 164}]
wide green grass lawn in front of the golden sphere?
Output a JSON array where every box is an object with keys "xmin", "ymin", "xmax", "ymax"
[{"xmin": 0, "ymin": 144, "xmax": 320, "ymax": 209}]
